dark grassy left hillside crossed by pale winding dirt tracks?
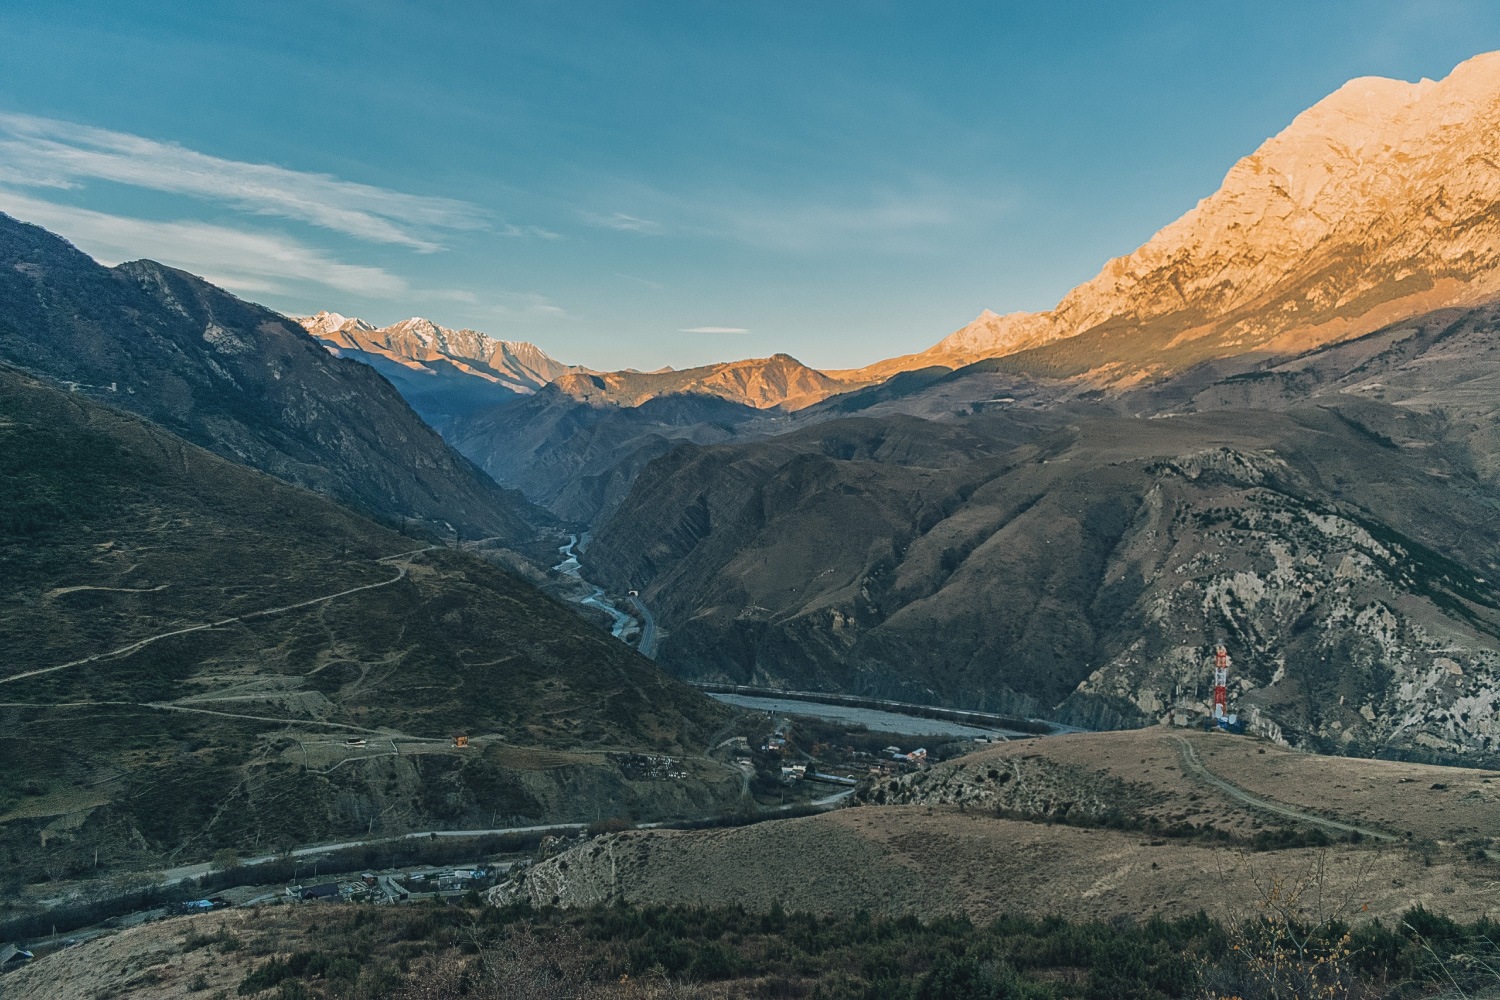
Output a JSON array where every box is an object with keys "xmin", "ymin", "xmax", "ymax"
[{"xmin": 0, "ymin": 367, "xmax": 740, "ymax": 881}]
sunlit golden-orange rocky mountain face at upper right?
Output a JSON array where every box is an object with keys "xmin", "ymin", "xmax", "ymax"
[{"xmin": 864, "ymin": 52, "xmax": 1500, "ymax": 381}]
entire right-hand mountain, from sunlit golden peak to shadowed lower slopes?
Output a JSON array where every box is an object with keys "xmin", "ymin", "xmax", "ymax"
[{"xmin": 567, "ymin": 55, "xmax": 1500, "ymax": 762}]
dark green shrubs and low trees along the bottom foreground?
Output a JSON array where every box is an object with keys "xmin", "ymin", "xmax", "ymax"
[{"xmin": 219, "ymin": 897, "xmax": 1500, "ymax": 1000}]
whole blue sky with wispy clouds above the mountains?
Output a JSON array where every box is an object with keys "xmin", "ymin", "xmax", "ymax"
[{"xmin": 0, "ymin": 0, "xmax": 1500, "ymax": 369}]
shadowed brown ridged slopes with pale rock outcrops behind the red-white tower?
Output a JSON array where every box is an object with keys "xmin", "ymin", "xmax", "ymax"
[{"xmin": 584, "ymin": 383, "xmax": 1500, "ymax": 762}]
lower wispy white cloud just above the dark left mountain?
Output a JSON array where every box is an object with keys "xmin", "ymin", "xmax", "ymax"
[{"xmin": 0, "ymin": 189, "xmax": 411, "ymax": 298}]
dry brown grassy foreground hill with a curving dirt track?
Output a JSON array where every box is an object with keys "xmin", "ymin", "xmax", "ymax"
[{"xmin": 491, "ymin": 727, "xmax": 1500, "ymax": 922}]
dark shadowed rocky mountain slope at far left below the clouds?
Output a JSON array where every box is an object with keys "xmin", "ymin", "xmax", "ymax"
[{"xmin": 0, "ymin": 216, "xmax": 546, "ymax": 540}]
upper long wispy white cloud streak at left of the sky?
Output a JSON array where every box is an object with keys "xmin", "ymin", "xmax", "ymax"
[{"xmin": 0, "ymin": 112, "xmax": 486, "ymax": 250}]
